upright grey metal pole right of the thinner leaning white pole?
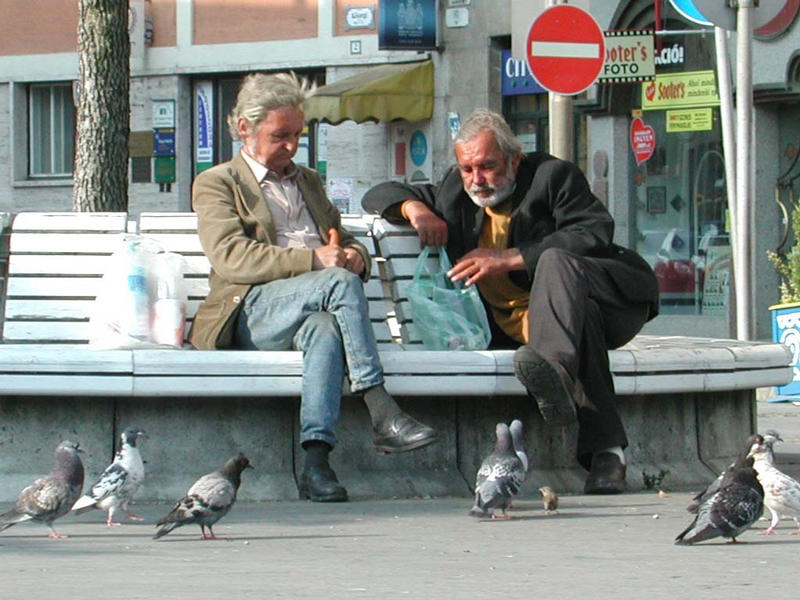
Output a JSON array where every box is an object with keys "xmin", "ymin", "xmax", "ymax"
[{"xmin": 734, "ymin": 0, "xmax": 753, "ymax": 340}]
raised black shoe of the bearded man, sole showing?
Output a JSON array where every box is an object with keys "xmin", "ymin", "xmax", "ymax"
[{"xmin": 514, "ymin": 346, "xmax": 578, "ymax": 426}]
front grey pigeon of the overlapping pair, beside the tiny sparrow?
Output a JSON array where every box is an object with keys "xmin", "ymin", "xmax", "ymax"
[{"xmin": 469, "ymin": 423, "xmax": 525, "ymax": 519}]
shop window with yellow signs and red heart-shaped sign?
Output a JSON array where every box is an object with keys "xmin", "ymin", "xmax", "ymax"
[{"xmin": 629, "ymin": 35, "xmax": 732, "ymax": 317}]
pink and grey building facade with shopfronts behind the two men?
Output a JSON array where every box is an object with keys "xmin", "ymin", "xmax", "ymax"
[{"xmin": 0, "ymin": 0, "xmax": 800, "ymax": 338}]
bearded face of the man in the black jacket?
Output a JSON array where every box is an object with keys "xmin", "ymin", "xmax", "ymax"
[{"xmin": 455, "ymin": 131, "xmax": 520, "ymax": 207}]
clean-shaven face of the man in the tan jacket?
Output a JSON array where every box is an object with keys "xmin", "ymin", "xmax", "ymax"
[{"xmin": 238, "ymin": 106, "xmax": 305, "ymax": 174}]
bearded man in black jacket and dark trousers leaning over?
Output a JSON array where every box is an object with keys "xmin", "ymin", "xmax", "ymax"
[{"xmin": 362, "ymin": 109, "xmax": 658, "ymax": 494}]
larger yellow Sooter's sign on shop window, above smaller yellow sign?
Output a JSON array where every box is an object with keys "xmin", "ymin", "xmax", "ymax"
[{"xmin": 642, "ymin": 71, "xmax": 719, "ymax": 110}]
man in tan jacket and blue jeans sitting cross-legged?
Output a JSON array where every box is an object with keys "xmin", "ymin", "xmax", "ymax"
[{"xmin": 189, "ymin": 73, "xmax": 437, "ymax": 502}]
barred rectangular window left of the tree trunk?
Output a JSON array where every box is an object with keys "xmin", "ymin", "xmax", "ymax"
[{"xmin": 28, "ymin": 84, "xmax": 75, "ymax": 177}]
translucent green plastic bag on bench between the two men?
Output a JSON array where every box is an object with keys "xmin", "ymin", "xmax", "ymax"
[{"xmin": 408, "ymin": 246, "xmax": 492, "ymax": 350}]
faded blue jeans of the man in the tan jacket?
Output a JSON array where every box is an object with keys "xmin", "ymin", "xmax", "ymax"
[{"xmin": 235, "ymin": 267, "xmax": 383, "ymax": 446}]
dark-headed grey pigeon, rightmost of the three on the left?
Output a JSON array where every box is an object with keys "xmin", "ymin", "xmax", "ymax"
[{"xmin": 153, "ymin": 452, "xmax": 253, "ymax": 540}]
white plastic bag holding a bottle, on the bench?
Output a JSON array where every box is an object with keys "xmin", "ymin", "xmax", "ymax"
[{"xmin": 89, "ymin": 234, "xmax": 186, "ymax": 349}]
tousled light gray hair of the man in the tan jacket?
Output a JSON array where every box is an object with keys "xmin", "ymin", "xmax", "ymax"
[{"xmin": 228, "ymin": 72, "xmax": 316, "ymax": 140}]
